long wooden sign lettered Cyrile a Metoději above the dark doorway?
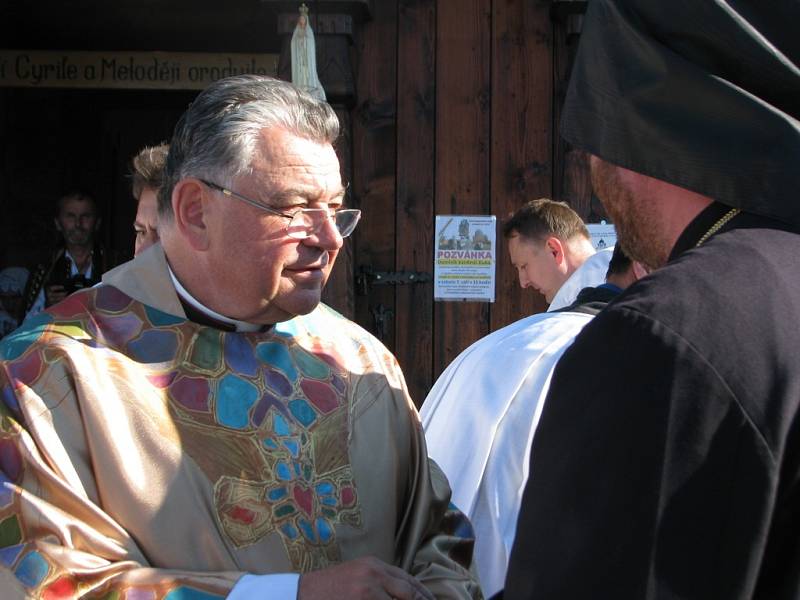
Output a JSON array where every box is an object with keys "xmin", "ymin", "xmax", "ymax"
[{"xmin": 0, "ymin": 50, "xmax": 278, "ymax": 90}]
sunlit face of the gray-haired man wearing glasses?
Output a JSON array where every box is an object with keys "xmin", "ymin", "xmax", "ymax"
[{"xmin": 205, "ymin": 128, "xmax": 344, "ymax": 324}]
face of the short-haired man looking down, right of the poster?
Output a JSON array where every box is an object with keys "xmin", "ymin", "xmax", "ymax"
[{"xmin": 508, "ymin": 234, "xmax": 567, "ymax": 304}]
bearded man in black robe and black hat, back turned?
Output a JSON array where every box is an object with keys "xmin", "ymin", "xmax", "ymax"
[{"xmin": 505, "ymin": 0, "xmax": 800, "ymax": 600}]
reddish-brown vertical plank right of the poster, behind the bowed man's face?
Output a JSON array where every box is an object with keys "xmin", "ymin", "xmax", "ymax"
[{"xmin": 491, "ymin": 0, "xmax": 553, "ymax": 331}]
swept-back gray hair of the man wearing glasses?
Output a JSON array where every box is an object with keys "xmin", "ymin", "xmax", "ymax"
[{"xmin": 158, "ymin": 75, "xmax": 339, "ymax": 219}]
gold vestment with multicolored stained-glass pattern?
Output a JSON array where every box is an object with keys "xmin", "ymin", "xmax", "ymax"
[{"xmin": 0, "ymin": 246, "xmax": 480, "ymax": 600}]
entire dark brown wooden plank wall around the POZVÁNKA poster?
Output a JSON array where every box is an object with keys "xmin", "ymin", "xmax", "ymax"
[{"xmin": 353, "ymin": 0, "xmax": 590, "ymax": 405}]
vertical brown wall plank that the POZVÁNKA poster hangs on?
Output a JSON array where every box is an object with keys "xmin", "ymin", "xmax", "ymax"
[{"xmin": 430, "ymin": 0, "xmax": 492, "ymax": 375}]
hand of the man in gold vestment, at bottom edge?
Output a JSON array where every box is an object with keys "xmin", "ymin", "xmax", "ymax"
[{"xmin": 297, "ymin": 556, "xmax": 435, "ymax": 600}]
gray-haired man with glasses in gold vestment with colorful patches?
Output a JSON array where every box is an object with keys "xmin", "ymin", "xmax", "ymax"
[{"xmin": 0, "ymin": 76, "xmax": 480, "ymax": 600}]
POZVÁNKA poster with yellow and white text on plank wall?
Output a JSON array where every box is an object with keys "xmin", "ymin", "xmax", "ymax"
[{"xmin": 433, "ymin": 215, "xmax": 497, "ymax": 302}]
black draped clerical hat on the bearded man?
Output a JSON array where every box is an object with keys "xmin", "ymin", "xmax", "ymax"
[{"xmin": 562, "ymin": 0, "xmax": 800, "ymax": 224}]
